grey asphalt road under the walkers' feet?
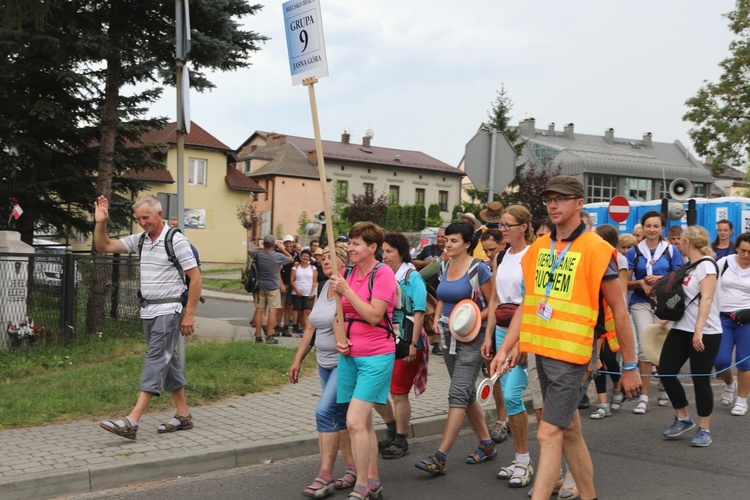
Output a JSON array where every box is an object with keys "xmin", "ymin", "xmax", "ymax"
[{"xmin": 63, "ymin": 398, "xmax": 750, "ymax": 500}]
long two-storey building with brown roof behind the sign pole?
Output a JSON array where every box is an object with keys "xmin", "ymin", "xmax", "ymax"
[{"xmin": 236, "ymin": 131, "xmax": 464, "ymax": 237}]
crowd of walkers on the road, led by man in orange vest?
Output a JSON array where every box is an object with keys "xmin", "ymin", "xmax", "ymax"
[{"xmin": 280, "ymin": 180, "xmax": 750, "ymax": 500}]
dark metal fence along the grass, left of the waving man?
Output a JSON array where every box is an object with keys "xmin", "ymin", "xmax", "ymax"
[{"xmin": 0, "ymin": 253, "xmax": 141, "ymax": 350}]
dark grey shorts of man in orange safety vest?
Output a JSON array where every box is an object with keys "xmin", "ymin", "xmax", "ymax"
[{"xmin": 536, "ymin": 356, "xmax": 587, "ymax": 429}]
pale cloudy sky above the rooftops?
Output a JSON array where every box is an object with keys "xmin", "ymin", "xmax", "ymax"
[{"xmin": 150, "ymin": 0, "xmax": 734, "ymax": 166}]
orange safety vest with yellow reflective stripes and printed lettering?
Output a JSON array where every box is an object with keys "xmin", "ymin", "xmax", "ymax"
[{"xmin": 520, "ymin": 231, "xmax": 616, "ymax": 365}]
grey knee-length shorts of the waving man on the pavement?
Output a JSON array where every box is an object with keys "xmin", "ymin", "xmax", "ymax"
[{"xmin": 140, "ymin": 313, "xmax": 187, "ymax": 396}]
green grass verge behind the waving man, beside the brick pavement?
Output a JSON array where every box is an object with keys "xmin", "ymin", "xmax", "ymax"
[{"xmin": 0, "ymin": 339, "xmax": 314, "ymax": 429}]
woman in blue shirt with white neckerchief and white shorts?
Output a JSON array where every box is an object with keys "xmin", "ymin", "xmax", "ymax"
[{"xmin": 626, "ymin": 210, "xmax": 682, "ymax": 415}]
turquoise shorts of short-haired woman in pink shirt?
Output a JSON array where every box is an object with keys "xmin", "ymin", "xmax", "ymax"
[{"xmin": 336, "ymin": 353, "xmax": 396, "ymax": 405}]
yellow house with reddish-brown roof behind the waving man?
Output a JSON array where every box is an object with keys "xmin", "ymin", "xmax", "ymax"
[{"xmin": 120, "ymin": 122, "xmax": 265, "ymax": 266}]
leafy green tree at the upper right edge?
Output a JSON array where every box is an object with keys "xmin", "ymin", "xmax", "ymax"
[{"xmin": 682, "ymin": 0, "xmax": 750, "ymax": 174}]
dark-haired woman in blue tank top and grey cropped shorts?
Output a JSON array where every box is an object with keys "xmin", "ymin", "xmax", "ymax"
[{"xmin": 415, "ymin": 222, "xmax": 497, "ymax": 474}]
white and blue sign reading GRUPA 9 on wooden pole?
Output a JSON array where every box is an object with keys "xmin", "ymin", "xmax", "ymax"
[{"xmin": 282, "ymin": 0, "xmax": 328, "ymax": 85}]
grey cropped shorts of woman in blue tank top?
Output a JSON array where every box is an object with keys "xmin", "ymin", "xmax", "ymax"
[{"xmin": 440, "ymin": 322, "xmax": 484, "ymax": 408}]
